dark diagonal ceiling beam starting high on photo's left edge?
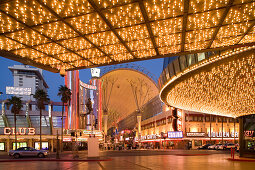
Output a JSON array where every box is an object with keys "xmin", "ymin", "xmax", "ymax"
[{"xmin": 0, "ymin": 9, "xmax": 94, "ymax": 65}]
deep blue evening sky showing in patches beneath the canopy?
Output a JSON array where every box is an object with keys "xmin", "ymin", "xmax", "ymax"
[{"xmin": 0, "ymin": 56, "xmax": 164, "ymax": 102}]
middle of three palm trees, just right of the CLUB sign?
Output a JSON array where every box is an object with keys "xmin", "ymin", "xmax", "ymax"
[{"xmin": 34, "ymin": 89, "xmax": 50, "ymax": 149}]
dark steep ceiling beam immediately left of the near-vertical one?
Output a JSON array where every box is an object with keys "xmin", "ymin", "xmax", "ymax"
[{"xmin": 139, "ymin": 0, "xmax": 159, "ymax": 55}]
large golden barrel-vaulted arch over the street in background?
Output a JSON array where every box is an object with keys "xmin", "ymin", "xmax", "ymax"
[{"xmin": 99, "ymin": 68, "xmax": 159, "ymax": 129}]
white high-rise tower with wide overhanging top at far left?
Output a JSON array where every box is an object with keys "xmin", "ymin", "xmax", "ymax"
[{"xmin": 8, "ymin": 65, "xmax": 49, "ymax": 101}]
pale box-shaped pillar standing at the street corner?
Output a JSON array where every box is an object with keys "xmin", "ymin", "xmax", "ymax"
[{"xmin": 88, "ymin": 135, "xmax": 99, "ymax": 158}]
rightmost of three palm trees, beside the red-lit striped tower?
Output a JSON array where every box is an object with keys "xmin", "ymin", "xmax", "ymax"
[{"xmin": 58, "ymin": 85, "xmax": 72, "ymax": 151}]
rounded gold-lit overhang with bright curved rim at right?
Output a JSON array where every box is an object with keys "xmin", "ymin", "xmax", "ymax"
[{"xmin": 160, "ymin": 46, "xmax": 255, "ymax": 118}]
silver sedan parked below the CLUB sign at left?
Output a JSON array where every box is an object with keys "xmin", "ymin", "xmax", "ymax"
[{"xmin": 9, "ymin": 147, "xmax": 48, "ymax": 159}]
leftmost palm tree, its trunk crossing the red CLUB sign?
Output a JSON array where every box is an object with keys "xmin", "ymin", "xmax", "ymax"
[{"xmin": 6, "ymin": 96, "xmax": 22, "ymax": 150}]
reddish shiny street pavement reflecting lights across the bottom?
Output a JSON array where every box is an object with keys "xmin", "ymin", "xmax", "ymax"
[{"xmin": 0, "ymin": 150, "xmax": 255, "ymax": 170}]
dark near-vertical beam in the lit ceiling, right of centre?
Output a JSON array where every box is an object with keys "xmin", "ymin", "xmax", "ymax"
[{"xmin": 181, "ymin": 0, "xmax": 189, "ymax": 52}]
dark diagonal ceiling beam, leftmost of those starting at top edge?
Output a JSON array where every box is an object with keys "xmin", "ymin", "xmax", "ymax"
[{"xmin": 35, "ymin": 0, "xmax": 114, "ymax": 61}]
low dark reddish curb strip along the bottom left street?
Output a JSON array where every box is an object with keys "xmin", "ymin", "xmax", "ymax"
[{"xmin": 0, "ymin": 158, "xmax": 112, "ymax": 163}]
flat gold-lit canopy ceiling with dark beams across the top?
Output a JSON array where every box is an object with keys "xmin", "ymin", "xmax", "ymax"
[{"xmin": 0, "ymin": 0, "xmax": 255, "ymax": 72}]
